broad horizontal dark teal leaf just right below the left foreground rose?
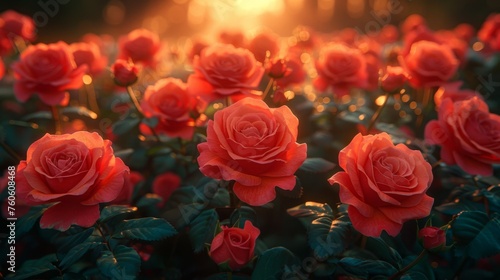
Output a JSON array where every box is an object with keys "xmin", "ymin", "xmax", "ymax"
[{"xmin": 112, "ymin": 218, "xmax": 177, "ymax": 241}]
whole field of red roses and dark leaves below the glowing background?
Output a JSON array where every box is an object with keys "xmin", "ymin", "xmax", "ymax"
[{"xmin": 0, "ymin": 7, "xmax": 500, "ymax": 280}]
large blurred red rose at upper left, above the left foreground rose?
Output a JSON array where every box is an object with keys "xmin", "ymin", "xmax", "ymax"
[{"xmin": 12, "ymin": 42, "xmax": 86, "ymax": 106}]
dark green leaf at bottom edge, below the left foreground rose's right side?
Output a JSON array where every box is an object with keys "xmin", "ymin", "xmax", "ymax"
[{"xmin": 97, "ymin": 245, "xmax": 141, "ymax": 280}]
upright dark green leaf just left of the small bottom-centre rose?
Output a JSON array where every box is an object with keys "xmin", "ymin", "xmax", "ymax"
[{"xmin": 189, "ymin": 209, "xmax": 219, "ymax": 253}]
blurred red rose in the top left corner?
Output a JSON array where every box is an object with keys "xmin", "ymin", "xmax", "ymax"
[{"xmin": 0, "ymin": 10, "xmax": 36, "ymax": 42}]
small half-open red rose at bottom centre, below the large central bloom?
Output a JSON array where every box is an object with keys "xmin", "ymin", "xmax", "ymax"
[{"xmin": 209, "ymin": 221, "xmax": 260, "ymax": 270}]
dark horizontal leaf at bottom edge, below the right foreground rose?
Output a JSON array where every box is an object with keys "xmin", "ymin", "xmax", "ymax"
[{"xmin": 339, "ymin": 258, "xmax": 397, "ymax": 279}]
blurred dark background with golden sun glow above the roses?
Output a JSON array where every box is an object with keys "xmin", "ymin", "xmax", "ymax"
[{"xmin": 0, "ymin": 0, "xmax": 500, "ymax": 43}]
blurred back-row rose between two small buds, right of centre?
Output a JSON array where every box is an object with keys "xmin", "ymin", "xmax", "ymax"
[{"xmin": 313, "ymin": 43, "xmax": 368, "ymax": 97}]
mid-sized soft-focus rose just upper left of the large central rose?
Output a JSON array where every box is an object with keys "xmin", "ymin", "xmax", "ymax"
[{"xmin": 141, "ymin": 78, "xmax": 198, "ymax": 140}]
